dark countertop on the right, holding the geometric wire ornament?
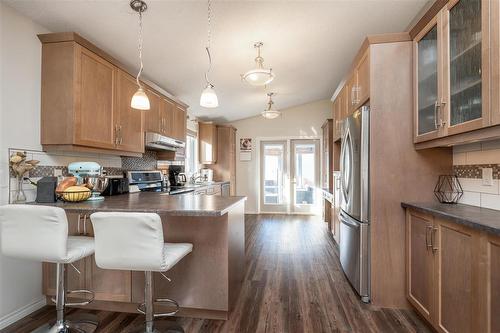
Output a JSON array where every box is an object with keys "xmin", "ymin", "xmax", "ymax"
[{"xmin": 401, "ymin": 202, "xmax": 500, "ymax": 235}]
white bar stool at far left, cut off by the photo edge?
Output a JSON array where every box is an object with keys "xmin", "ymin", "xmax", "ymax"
[{"xmin": 0, "ymin": 205, "xmax": 97, "ymax": 333}]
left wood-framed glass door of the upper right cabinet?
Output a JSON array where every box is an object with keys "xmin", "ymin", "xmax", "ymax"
[{"xmin": 413, "ymin": 15, "xmax": 442, "ymax": 142}]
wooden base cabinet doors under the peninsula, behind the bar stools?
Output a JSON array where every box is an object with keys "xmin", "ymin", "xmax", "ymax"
[{"xmin": 43, "ymin": 213, "xmax": 132, "ymax": 302}]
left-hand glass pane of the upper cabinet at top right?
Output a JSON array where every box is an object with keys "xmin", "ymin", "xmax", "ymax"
[{"xmin": 417, "ymin": 25, "xmax": 438, "ymax": 135}]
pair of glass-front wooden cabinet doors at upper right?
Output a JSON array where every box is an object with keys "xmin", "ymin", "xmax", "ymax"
[{"xmin": 414, "ymin": 0, "xmax": 490, "ymax": 142}]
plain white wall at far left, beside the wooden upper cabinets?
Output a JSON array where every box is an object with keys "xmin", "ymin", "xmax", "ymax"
[{"xmin": 0, "ymin": 2, "xmax": 47, "ymax": 329}]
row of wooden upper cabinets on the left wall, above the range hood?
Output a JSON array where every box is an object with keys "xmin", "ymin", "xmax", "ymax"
[{"xmin": 38, "ymin": 33, "xmax": 186, "ymax": 156}]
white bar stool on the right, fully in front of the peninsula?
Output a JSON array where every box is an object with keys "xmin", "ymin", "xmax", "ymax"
[{"xmin": 90, "ymin": 212, "xmax": 193, "ymax": 333}]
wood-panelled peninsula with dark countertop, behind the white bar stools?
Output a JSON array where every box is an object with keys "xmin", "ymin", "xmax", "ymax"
[{"xmin": 34, "ymin": 193, "xmax": 246, "ymax": 320}]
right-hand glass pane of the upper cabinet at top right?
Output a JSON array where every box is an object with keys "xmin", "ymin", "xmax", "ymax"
[{"xmin": 448, "ymin": 0, "xmax": 482, "ymax": 126}]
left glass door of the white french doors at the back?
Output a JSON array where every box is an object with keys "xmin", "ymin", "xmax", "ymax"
[{"xmin": 260, "ymin": 141, "xmax": 288, "ymax": 212}]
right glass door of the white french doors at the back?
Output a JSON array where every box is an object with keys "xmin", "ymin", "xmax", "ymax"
[{"xmin": 291, "ymin": 140, "xmax": 320, "ymax": 213}]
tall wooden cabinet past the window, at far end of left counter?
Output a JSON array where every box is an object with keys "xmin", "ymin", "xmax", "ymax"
[{"xmin": 210, "ymin": 125, "xmax": 236, "ymax": 195}]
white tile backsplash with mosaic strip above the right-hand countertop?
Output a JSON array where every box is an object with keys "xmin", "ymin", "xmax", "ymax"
[{"xmin": 453, "ymin": 140, "xmax": 500, "ymax": 210}]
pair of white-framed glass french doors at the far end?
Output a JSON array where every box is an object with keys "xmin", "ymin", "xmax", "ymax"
[{"xmin": 260, "ymin": 139, "xmax": 320, "ymax": 214}]
